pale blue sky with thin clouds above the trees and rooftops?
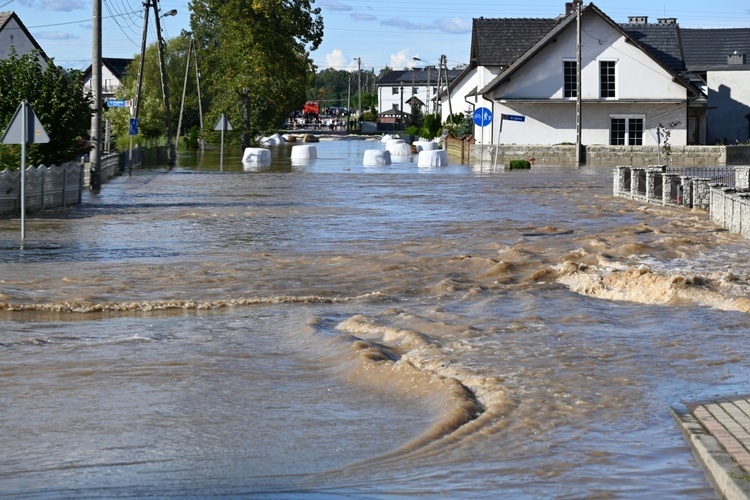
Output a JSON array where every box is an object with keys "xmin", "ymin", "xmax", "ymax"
[{"xmin": 5, "ymin": 0, "xmax": 750, "ymax": 72}]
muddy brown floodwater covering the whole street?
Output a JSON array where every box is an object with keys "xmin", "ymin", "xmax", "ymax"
[{"xmin": 0, "ymin": 139, "xmax": 750, "ymax": 499}]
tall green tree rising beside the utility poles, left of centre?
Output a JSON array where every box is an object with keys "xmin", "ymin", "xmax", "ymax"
[{"xmin": 190, "ymin": 0, "xmax": 323, "ymax": 147}]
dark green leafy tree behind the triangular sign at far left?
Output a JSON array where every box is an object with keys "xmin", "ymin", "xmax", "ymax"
[{"xmin": 0, "ymin": 51, "xmax": 92, "ymax": 170}]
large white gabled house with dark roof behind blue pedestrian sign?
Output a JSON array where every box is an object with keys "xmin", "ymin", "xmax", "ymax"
[{"xmin": 450, "ymin": 4, "xmax": 708, "ymax": 146}]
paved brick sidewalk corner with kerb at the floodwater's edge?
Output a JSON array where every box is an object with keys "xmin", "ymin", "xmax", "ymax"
[{"xmin": 673, "ymin": 396, "xmax": 750, "ymax": 500}]
